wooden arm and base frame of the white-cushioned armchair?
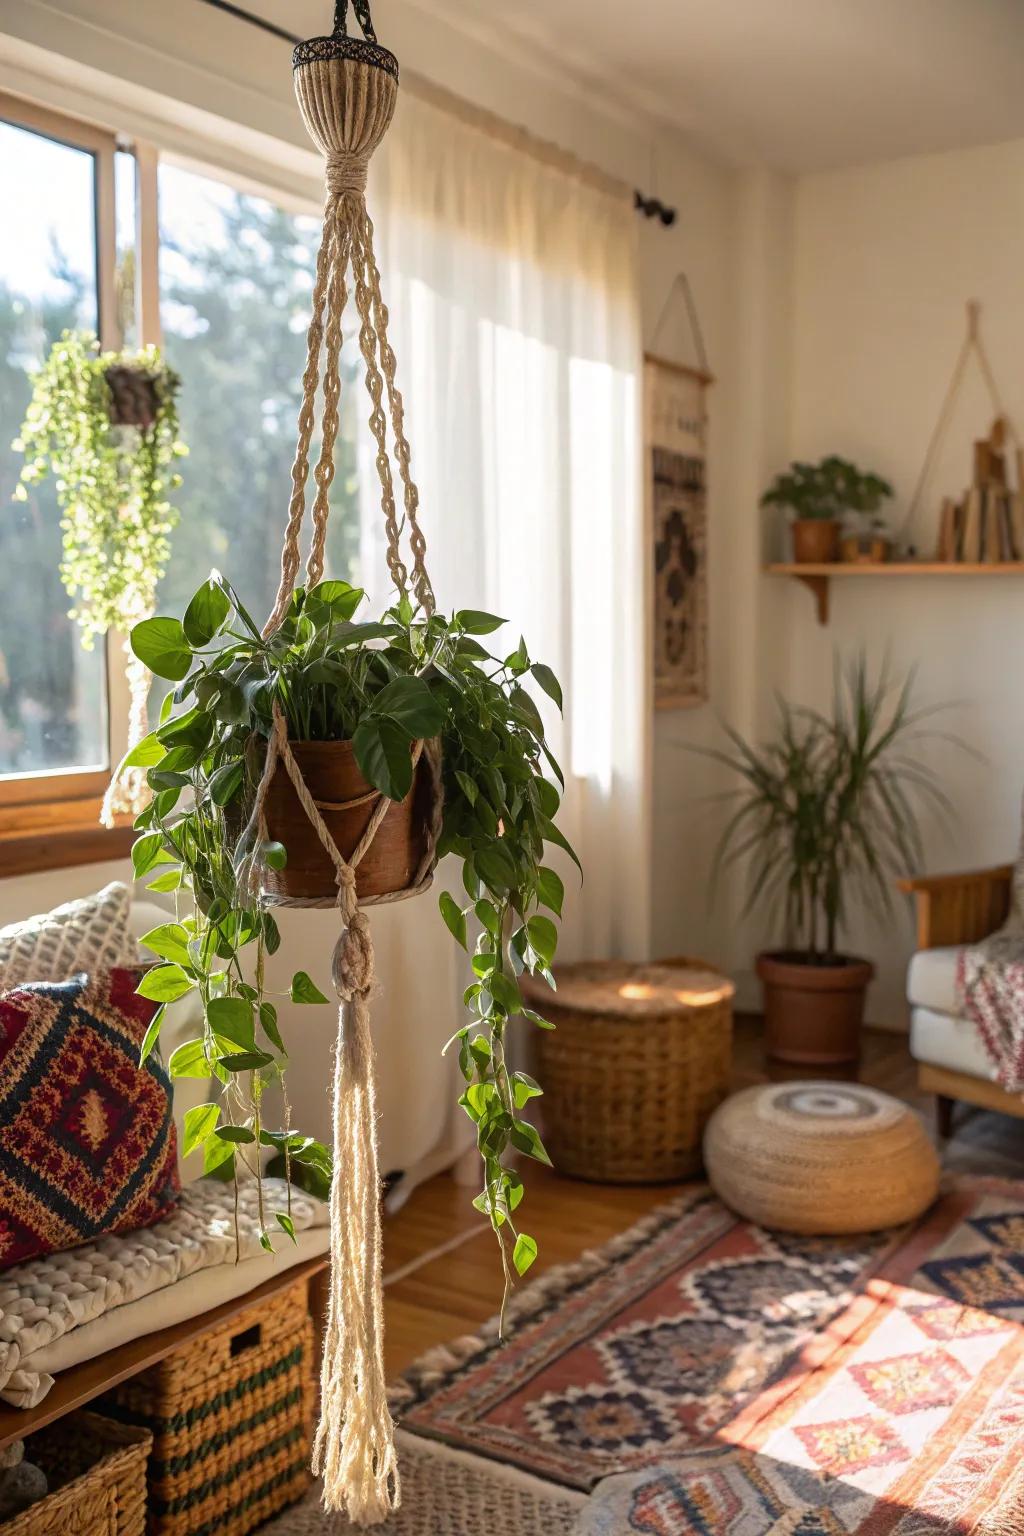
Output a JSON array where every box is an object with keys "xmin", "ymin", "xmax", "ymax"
[{"xmin": 900, "ymin": 865, "xmax": 1024, "ymax": 1137}]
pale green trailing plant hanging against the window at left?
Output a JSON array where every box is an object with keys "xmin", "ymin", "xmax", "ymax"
[{"xmin": 14, "ymin": 330, "xmax": 186, "ymax": 826}]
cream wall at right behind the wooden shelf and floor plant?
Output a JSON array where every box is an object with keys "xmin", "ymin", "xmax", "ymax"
[{"xmin": 776, "ymin": 141, "xmax": 1024, "ymax": 1026}]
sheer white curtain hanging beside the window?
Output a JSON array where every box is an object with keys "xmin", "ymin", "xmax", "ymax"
[{"xmin": 280, "ymin": 84, "xmax": 649, "ymax": 1191}]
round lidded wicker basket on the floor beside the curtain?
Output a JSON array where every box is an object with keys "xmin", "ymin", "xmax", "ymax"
[{"xmin": 527, "ymin": 958, "xmax": 734, "ymax": 1184}]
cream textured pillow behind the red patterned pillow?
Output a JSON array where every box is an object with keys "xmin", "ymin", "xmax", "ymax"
[{"xmin": 0, "ymin": 882, "xmax": 138, "ymax": 992}]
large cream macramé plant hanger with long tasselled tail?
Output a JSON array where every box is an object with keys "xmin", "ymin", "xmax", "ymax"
[{"xmin": 238, "ymin": 0, "xmax": 442, "ymax": 1525}]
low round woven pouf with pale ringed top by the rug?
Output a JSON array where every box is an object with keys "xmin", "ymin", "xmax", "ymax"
[{"xmin": 705, "ymin": 1083, "xmax": 940, "ymax": 1236}]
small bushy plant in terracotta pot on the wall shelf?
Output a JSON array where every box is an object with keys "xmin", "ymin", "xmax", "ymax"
[{"xmin": 761, "ymin": 455, "xmax": 892, "ymax": 565}]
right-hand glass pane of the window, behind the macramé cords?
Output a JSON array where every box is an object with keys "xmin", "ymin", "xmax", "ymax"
[{"xmin": 160, "ymin": 164, "xmax": 358, "ymax": 622}]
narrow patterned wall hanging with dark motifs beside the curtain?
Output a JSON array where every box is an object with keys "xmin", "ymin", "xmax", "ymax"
[{"xmin": 643, "ymin": 272, "xmax": 714, "ymax": 710}]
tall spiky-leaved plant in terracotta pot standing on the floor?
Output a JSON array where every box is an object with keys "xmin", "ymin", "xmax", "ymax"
[{"xmin": 712, "ymin": 657, "xmax": 949, "ymax": 1072}]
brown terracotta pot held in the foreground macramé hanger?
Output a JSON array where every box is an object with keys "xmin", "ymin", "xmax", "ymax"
[{"xmin": 263, "ymin": 742, "xmax": 431, "ymax": 902}]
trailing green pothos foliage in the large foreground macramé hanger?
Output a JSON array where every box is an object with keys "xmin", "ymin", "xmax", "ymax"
[{"xmin": 123, "ymin": 571, "xmax": 579, "ymax": 1296}]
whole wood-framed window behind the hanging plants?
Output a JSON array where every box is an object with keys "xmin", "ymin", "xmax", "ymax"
[{"xmin": 0, "ymin": 97, "xmax": 361, "ymax": 874}]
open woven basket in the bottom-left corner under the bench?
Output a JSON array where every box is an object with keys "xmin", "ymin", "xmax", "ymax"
[{"xmin": 0, "ymin": 1413, "xmax": 152, "ymax": 1536}]
